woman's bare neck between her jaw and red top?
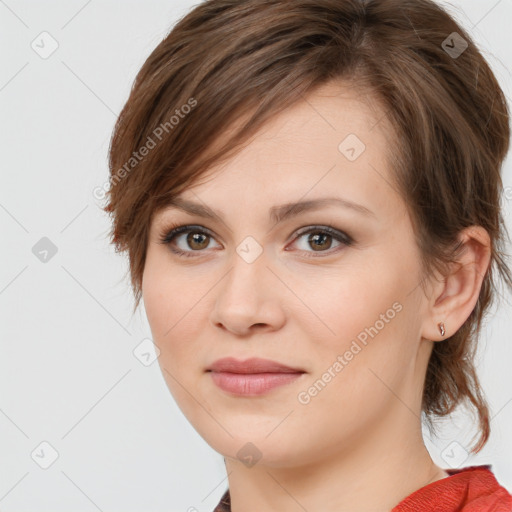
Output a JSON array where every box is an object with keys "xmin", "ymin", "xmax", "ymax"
[{"xmin": 225, "ymin": 401, "xmax": 448, "ymax": 512}]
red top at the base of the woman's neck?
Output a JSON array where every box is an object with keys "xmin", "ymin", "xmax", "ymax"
[{"xmin": 213, "ymin": 465, "xmax": 512, "ymax": 512}]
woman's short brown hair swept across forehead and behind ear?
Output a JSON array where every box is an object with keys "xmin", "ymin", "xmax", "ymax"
[{"xmin": 104, "ymin": 0, "xmax": 512, "ymax": 453}]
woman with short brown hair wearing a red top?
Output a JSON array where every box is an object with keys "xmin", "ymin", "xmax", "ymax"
[{"xmin": 105, "ymin": 0, "xmax": 512, "ymax": 512}]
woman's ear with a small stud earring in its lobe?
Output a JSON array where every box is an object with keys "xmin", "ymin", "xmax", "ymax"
[{"xmin": 421, "ymin": 226, "xmax": 491, "ymax": 341}]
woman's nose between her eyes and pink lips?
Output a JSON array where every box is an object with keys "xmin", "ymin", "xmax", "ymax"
[{"xmin": 211, "ymin": 247, "xmax": 286, "ymax": 336}]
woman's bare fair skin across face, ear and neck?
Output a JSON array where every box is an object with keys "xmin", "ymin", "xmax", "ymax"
[{"xmin": 142, "ymin": 83, "xmax": 489, "ymax": 512}]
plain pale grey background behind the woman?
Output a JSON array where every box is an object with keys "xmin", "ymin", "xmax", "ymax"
[{"xmin": 0, "ymin": 0, "xmax": 512, "ymax": 512}]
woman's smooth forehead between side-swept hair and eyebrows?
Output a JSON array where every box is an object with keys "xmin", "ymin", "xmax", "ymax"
[{"xmin": 158, "ymin": 83, "xmax": 402, "ymax": 221}]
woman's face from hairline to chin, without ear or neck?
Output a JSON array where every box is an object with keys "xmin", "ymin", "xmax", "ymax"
[{"xmin": 142, "ymin": 84, "xmax": 432, "ymax": 467}]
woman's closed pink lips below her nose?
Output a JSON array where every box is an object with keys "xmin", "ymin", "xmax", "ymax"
[{"xmin": 207, "ymin": 357, "xmax": 305, "ymax": 396}]
